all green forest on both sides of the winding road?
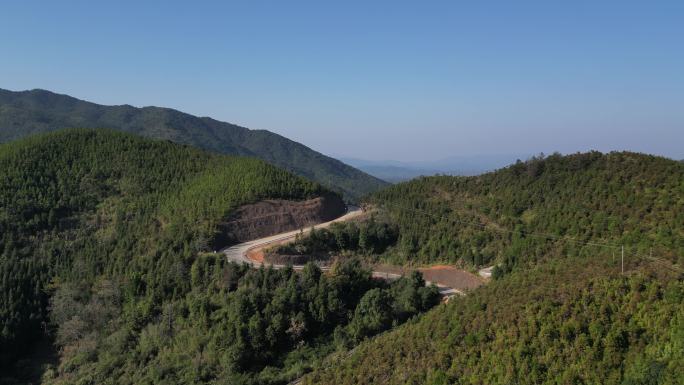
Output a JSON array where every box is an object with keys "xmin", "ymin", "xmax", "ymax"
[{"xmin": 0, "ymin": 135, "xmax": 684, "ymax": 385}]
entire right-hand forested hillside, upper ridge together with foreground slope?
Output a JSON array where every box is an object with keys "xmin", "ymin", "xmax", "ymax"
[{"xmin": 302, "ymin": 152, "xmax": 684, "ymax": 384}]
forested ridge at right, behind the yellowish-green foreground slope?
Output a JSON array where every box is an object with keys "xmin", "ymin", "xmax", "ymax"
[{"xmin": 370, "ymin": 152, "xmax": 684, "ymax": 270}]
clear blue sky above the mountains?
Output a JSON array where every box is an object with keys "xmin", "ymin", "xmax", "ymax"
[{"xmin": 0, "ymin": 0, "xmax": 684, "ymax": 161}]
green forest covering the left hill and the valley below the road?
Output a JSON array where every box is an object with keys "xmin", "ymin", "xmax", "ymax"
[{"xmin": 0, "ymin": 130, "xmax": 437, "ymax": 384}]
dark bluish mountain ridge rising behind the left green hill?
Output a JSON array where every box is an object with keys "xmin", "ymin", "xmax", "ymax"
[{"xmin": 0, "ymin": 89, "xmax": 385, "ymax": 199}]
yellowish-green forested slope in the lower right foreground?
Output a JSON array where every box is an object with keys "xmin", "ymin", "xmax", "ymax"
[{"xmin": 303, "ymin": 255, "xmax": 684, "ymax": 385}]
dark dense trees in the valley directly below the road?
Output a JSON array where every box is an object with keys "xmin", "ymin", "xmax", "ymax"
[{"xmin": 44, "ymin": 254, "xmax": 438, "ymax": 385}]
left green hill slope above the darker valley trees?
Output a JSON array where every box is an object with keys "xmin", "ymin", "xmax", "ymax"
[{"xmin": 0, "ymin": 130, "xmax": 326, "ymax": 372}]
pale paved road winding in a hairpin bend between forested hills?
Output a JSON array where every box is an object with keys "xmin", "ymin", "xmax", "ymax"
[{"xmin": 221, "ymin": 209, "xmax": 465, "ymax": 296}]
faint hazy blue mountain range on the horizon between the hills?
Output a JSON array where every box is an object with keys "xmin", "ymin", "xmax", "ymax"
[{"xmin": 339, "ymin": 154, "xmax": 531, "ymax": 183}]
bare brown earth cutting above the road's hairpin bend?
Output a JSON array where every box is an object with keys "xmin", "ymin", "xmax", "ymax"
[{"xmin": 214, "ymin": 194, "xmax": 347, "ymax": 249}]
